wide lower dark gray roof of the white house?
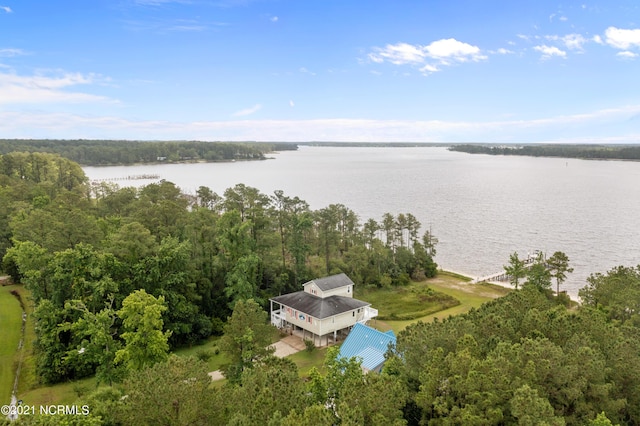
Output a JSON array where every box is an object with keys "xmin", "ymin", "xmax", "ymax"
[{"xmin": 270, "ymin": 291, "xmax": 371, "ymax": 319}]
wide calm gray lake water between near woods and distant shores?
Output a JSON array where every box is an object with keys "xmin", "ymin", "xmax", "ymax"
[{"xmin": 84, "ymin": 146, "xmax": 640, "ymax": 296}]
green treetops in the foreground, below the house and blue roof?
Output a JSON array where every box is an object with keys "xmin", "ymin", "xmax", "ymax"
[{"xmin": 5, "ymin": 267, "xmax": 640, "ymax": 426}]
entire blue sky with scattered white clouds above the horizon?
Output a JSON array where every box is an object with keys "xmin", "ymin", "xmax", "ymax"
[{"xmin": 0, "ymin": 0, "xmax": 640, "ymax": 143}]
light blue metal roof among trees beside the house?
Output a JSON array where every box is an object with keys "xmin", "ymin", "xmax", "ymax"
[{"xmin": 338, "ymin": 323, "xmax": 396, "ymax": 370}]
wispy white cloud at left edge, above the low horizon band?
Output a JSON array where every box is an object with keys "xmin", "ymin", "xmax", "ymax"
[{"xmin": 0, "ymin": 73, "xmax": 116, "ymax": 104}]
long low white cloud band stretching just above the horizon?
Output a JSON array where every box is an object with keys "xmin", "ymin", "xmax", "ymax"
[{"xmin": 0, "ymin": 105, "xmax": 640, "ymax": 143}]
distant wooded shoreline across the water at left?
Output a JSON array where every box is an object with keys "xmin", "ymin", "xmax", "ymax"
[{"xmin": 0, "ymin": 139, "xmax": 297, "ymax": 166}]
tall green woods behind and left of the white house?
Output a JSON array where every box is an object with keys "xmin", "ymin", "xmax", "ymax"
[{"xmin": 0, "ymin": 153, "xmax": 437, "ymax": 383}]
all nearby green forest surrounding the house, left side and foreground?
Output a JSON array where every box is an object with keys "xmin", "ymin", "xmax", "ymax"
[{"xmin": 0, "ymin": 153, "xmax": 640, "ymax": 426}]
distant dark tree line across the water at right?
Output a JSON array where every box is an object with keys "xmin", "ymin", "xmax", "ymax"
[{"xmin": 449, "ymin": 144, "xmax": 640, "ymax": 161}]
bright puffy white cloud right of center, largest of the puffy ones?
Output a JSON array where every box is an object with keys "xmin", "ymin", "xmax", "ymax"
[{"xmin": 368, "ymin": 38, "xmax": 487, "ymax": 73}]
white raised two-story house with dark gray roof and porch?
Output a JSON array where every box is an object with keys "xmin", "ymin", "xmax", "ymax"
[{"xmin": 269, "ymin": 274, "xmax": 378, "ymax": 346}]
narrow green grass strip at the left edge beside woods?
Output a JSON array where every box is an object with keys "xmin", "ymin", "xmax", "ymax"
[{"xmin": 0, "ymin": 285, "xmax": 22, "ymax": 405}]
